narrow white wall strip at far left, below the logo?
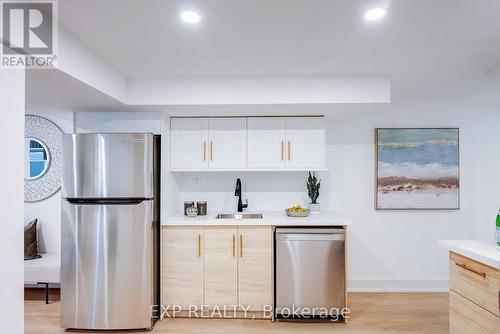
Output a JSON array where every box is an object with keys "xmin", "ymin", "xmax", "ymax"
[{"xmin": 0, "ymin": 70, "xmax": 25, "ymax": 334}]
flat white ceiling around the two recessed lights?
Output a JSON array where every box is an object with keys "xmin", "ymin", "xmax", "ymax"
[{"xmin": 59, "ymin": 0, "xmax": 500, "ymax": 101}]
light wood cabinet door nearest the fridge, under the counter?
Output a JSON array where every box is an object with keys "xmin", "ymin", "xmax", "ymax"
[{"xmin": 163, "ymin": 226, "xmax": 204, "ymax": 310}]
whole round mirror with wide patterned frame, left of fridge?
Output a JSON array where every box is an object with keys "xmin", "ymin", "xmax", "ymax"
[{"xmin": 24, "ymin": 115, "xmax": 63, "ymax": 202}]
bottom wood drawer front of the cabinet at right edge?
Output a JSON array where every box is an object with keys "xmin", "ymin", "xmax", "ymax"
[{"xmin": 450, "ymin": 290, "xmax": 500, "ymax": 334}]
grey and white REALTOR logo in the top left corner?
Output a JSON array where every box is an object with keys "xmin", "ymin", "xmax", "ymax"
[{"xmin": 1, "ymin": 0, "xmax": 57, "ymax": 68}]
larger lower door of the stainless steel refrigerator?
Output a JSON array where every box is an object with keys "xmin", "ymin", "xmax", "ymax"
[{"xmin": 61, "ymin": 200, "xmax": 155, "ymax": 330}]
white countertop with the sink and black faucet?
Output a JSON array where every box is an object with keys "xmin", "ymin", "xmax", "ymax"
[{"xmin": 161, "ymin": 210, "xmax": 352, "ymax": 226}]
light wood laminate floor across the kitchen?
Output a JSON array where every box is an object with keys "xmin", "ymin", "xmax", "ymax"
[{"xmin": 24, "ymin": 293, "xmax": 448, "ymax": 334}]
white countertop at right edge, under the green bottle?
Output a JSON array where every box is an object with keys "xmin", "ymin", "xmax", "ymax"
[{"xmin": 439, "ymin": 240, "xmax": 500, "ymax": 269}]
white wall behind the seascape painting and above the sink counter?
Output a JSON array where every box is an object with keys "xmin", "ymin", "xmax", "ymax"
[{"xmin": 168, "ymin": 101, "xmax": 500, "ymax": 290}]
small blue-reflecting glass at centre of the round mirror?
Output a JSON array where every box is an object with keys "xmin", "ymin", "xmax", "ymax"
[{"xmin": 24, "ymin": 138, "xmax": 50, "ymax": 180}]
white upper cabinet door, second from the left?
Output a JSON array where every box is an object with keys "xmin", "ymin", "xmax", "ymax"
[{"xmin": 208, "ymin": 117, "xmax": 247, "ymax": 169}]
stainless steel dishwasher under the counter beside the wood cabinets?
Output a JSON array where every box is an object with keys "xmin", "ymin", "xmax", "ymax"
[{"xmin": 275, "ymin": 228, "xmax": 346, "ymax": 319}]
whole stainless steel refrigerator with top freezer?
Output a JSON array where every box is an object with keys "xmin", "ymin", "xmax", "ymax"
[{"xmin": 61, "ymin": 133, "xmax": 160, "ymax": 330}]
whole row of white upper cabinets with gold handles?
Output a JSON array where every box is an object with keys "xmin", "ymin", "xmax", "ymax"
[{"xmin": 170, "ymin": 117, "xmax": 326, "ymax": 171}]
